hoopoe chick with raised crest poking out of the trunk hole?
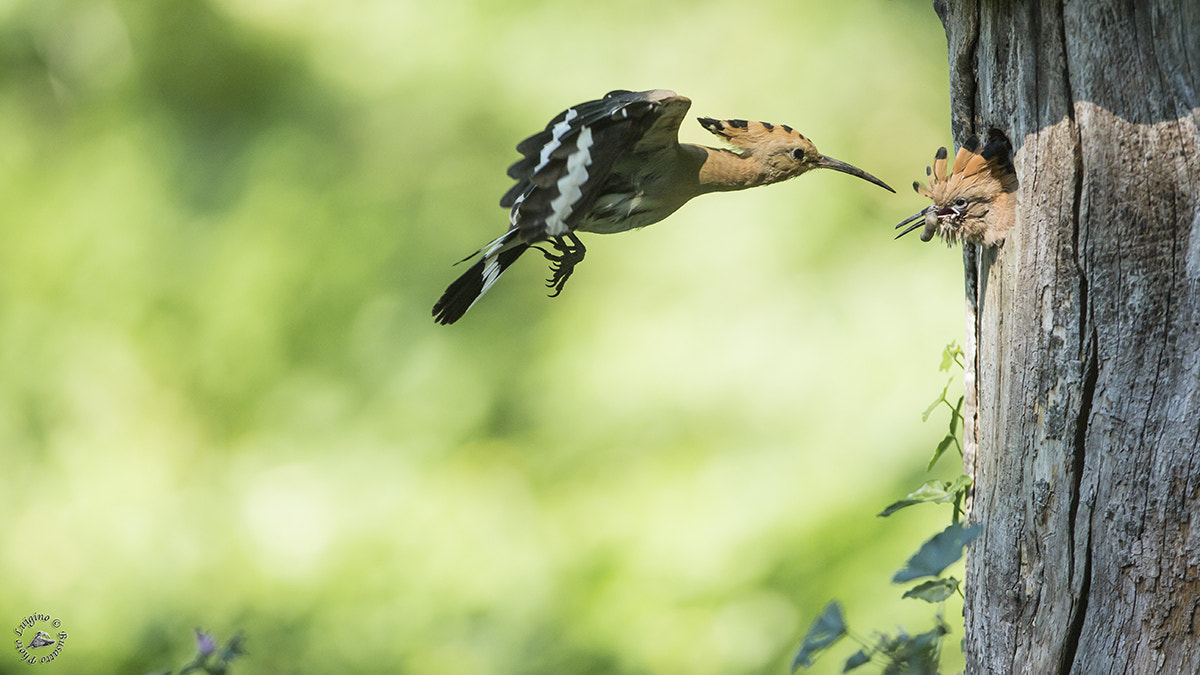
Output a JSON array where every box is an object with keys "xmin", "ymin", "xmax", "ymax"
[{"xmin": 896, "ymin": 136, "xmax": 1016, "ymax": 246}]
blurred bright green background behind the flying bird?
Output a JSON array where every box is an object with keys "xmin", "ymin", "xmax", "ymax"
[{"xmin": 0, "ymin": 0, "xmax": 962, "ymax": 674}]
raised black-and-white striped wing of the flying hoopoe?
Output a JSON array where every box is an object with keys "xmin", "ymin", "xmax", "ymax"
[{"xmin": 500, "ymin": 90, "xmax": 674, "ymax": 243}]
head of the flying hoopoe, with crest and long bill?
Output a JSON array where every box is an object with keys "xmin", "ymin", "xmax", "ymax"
[{"xmin": 700, "ymin": 118, "xmax": 895, "ymax": 192}]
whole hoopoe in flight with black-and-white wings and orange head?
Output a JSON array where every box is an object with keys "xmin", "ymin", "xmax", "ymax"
[{"xmin": 433, "ymin": 89, "xmax": 895, "ymax": 324}]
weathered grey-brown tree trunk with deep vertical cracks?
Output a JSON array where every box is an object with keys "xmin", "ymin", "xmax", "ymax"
[{"xmin": 934, "ymin": 0, "xmax": 1200, "ymax": 674}]
